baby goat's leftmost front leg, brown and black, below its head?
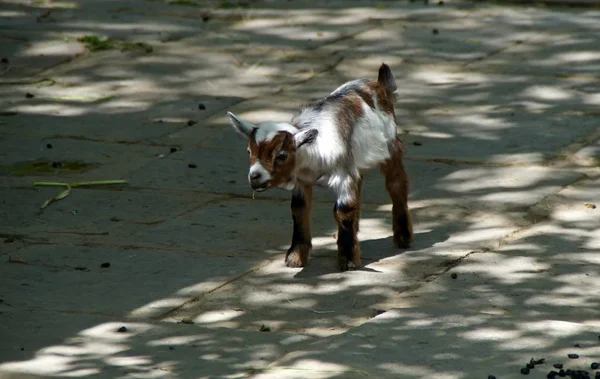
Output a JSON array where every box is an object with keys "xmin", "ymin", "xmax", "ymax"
[{"xmin": 285, "ymin": 185, "xmax": 312, "ymax": 267}]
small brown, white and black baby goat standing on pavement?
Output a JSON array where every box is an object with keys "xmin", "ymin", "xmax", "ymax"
[{"xmin": 228, "ymin": 64, "xmax": 413, "ymax": 271}]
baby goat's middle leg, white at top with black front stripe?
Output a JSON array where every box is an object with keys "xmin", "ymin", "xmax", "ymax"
[{"xmin": 333, "ymin": 177, "xmax": 362, "ymax": 271}]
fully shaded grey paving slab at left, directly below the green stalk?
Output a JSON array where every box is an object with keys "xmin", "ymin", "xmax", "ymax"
[{"xmin": 0, "ymin": 187, "xmax": 223, "ymax": 244}]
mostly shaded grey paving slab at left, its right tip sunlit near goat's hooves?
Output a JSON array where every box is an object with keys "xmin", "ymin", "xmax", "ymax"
[{"xmin": 0, "ymin": 245, "xmax": 258, "ymax": 317}]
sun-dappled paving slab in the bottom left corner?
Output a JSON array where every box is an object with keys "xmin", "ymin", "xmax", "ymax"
[{"xmin": 0, "ymin": 318, "xmax": 318, "ymax": 379}]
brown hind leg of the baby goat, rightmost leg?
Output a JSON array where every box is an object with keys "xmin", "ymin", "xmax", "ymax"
[{"xmin": 381, "ymin": 139, "xmax": 413, "ymax": 248}]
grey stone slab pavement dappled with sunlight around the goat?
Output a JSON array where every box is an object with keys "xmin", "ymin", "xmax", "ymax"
[{"xmin": 0, "ymin": 0, "xmax": 600, "ymax": 379}]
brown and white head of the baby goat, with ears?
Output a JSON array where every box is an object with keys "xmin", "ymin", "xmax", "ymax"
[{"xmin": 227, "ymin": 112, "xmax": 318, "ymax": 191}]
